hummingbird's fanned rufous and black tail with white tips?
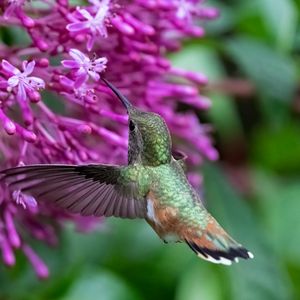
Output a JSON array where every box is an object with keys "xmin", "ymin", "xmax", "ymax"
[{"xmin": 185, "ymin": 219, "xmax": 254, "ymax": 265}]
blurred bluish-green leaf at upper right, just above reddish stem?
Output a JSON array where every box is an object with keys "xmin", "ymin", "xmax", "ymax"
[{"xmin": 225, "ymin": 36, "xmax": 296, "ymax": 103}]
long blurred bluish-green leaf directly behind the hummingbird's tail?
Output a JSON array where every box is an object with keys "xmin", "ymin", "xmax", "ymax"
[{"xmin": 204, "ymin": 166, "xmax": 291, "ymax": 300}]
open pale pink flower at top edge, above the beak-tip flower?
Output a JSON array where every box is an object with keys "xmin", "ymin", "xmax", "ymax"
[{"xmin": 66, "ymin": 0, "xmax": 110, "ymax": 51}]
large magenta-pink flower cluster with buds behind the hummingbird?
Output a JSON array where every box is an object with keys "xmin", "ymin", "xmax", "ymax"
[{"xmin": 0, "ymin": 0, "xmax": 218, "ymax": 277}]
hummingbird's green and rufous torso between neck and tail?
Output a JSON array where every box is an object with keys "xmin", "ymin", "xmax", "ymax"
[{"xmin": 146, "ymin": 161, "xmax": 209, "ymax": 241}]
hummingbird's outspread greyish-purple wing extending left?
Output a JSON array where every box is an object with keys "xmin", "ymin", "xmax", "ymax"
[{"xmin": 0, "ymin": 165, "xmax": 146, "ymax": 218}]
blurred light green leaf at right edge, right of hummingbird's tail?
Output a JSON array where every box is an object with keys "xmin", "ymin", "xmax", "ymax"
[{"xmin": 253, "ymin": 171, "xmax": 300, "ymax": 267}]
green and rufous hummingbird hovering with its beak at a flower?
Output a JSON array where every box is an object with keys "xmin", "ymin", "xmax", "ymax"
[{"xmin": 0, "ymin": 77, "xmax": 253, "ymax": 265}]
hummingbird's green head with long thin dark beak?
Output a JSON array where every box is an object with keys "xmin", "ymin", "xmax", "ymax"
[{"xmin": 102, "ymin": 77, "xmax": 171, "ymax": 166}]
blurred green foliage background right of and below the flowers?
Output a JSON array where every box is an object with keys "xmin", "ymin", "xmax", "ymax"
[{"xmin": 0, "ymin": 0, "xmax": 300, "ymax": 300}]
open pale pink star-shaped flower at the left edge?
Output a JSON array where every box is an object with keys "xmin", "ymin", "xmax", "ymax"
[{"xmin": 2, "ymin": 59, "xmax": 45, "ymax": 101}]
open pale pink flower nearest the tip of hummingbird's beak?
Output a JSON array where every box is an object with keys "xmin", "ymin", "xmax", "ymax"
[{"xmin": 62, "ymin": 49, "xmax": 107, "ymax": 88}]
